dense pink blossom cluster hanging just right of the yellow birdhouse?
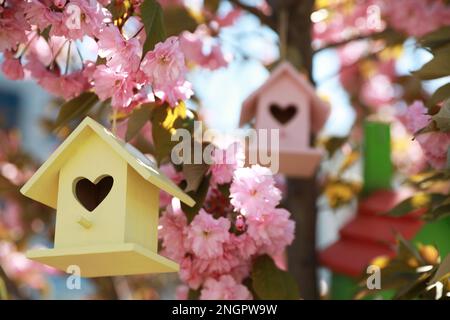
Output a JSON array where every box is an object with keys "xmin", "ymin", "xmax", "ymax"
[{"xmin": 159, "ymin": 144, "xmax": 295, "ymax": 299}]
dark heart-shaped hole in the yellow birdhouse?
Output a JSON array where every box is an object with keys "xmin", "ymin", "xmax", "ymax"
[{"xmin": 75, "ymin": 176, "xmax": 114, "ymax": 212}]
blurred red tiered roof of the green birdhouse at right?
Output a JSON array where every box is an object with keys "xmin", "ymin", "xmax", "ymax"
[{"xmin": 319, "ymin": 191, "xmax": 423, "ymax": 277}]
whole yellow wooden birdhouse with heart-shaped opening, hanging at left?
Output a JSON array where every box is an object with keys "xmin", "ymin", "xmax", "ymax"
[{"xmin": 21, "ymin": 118, "xmax": 195, "ymax": 277}]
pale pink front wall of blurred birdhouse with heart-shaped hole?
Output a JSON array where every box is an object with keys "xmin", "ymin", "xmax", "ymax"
[{"xmin": 255, "ymin": 75, "xmax": 310, "ymax": 151}]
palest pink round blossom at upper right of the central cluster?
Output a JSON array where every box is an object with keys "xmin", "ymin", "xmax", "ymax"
[{"xmin": 230, "ymin": 165, "xmax": 281, "ymax": 216}]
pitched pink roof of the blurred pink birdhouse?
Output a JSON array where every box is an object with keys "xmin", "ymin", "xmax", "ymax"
[{"xmin": 240, "ymin": 62, "xmax": 330, "ymax": 133}]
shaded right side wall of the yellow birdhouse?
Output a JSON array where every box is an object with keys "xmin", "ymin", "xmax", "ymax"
[{"xmin": 125, "ymin": 166, "xmax": 160, "ymax": 252}]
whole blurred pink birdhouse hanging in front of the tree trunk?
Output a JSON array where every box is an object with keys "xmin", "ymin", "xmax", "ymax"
[{"xmin": 240, "ymin": 62, "xmax": 330, "ymax": 177}]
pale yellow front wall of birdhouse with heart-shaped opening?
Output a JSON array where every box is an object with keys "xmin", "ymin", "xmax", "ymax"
[{"xmin": 55, "ymin": 132, "xmax": 128, "ymax": 248}]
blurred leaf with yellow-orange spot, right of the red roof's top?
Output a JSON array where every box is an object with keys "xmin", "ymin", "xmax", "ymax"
[{"xmin": 382, "ymin": 192, "xmax": 446, "ymax": 217}]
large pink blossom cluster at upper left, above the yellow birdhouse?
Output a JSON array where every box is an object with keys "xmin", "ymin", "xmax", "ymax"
[{"xmin": 0, "ymin": 0, "xmax": 228, "ymax": 110}]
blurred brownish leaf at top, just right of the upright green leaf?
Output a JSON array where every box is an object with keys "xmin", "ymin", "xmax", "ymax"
[{"xmin": 164, "ymin": 6, "xmax": 198, "ymax": 37}]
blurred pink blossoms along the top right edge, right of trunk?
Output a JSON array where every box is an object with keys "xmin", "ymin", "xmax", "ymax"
[{"xmin": 312, "ymin": 0, "xmax": 450, "ymax": 46}]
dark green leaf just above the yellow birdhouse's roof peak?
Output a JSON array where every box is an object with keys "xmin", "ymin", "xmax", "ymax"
[{"xmin": 55, "ymin": 92, "xmax": 98, "ymax": 130}]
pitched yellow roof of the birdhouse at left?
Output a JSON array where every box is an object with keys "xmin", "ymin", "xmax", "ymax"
[{"xmin": 20, "ymin": 117, "xmax": 195, "ymax": 208}]
